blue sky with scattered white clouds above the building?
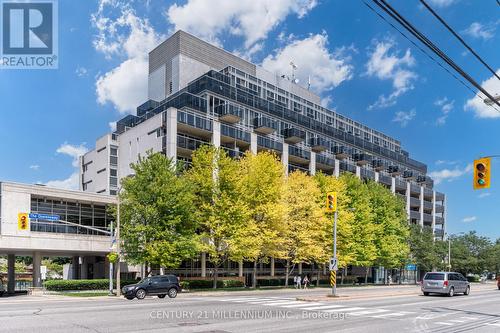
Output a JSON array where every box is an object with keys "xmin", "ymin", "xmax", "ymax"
[{"xmin": 0, "ymin": 0, "xmax": 500, "ymax": 238}]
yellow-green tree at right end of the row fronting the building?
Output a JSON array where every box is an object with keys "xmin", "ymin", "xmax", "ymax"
[{"xmin": 367, "ymin": 182, "xmax": 410, "ymax": 283}]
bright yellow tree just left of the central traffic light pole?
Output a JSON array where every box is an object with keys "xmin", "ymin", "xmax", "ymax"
[{"xmin": 283, "ymin": 171, "xmax": 331, "ymax": 286}]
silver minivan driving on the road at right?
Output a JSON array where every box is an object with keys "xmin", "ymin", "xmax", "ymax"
[{"xmin": 422, "ymin": 272, "xmax": 470, "ymax": 297}]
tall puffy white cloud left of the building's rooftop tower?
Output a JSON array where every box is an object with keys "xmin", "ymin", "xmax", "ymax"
[{"xmin": 92, "ymin": 0, "xmax": 164, "ymax": 113}]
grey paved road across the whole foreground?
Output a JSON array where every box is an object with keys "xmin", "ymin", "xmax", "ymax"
[{"xmin": 0, "ymin": 284, "xmax": 500, "ymax": 333}]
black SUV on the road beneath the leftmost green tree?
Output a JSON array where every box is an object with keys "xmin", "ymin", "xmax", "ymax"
[{"xmin": 122, "ymin": 274, "xmax": 181, "ymax": 300}]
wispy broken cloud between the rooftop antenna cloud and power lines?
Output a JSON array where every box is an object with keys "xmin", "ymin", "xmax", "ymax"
[{"xmin": 366, "ymin": 39, "xmax": 417, "ymax": 110}]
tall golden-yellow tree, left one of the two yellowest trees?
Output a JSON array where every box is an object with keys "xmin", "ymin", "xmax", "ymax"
[{"xmin": 240, "ymin": 152, "xmax": 286, "ymax": 287}]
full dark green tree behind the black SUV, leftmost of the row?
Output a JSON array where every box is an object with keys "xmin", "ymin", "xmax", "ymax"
[{"xmin": 120, "ymin": 153, "xmax": 198, "ymax": 268}]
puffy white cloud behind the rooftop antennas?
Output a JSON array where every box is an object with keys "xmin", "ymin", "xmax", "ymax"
[{"xmin": 262, "ymin": 33, "xmax": 353, "ymax": 94}]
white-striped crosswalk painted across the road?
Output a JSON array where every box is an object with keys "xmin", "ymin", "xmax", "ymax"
[{"xmin": 216, "ymin": 297, "xmax": 414, "ymax": 319}]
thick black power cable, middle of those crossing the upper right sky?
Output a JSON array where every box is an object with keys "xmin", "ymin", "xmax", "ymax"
[{"xmin": 372, "ymin": 0, "xmax": 500, "ymax": 106}]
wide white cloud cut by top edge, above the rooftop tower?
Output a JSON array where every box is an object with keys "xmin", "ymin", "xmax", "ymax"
[{"xmin": 166, "ymin": 0, "xmax": 317, "ymax": 48}]
